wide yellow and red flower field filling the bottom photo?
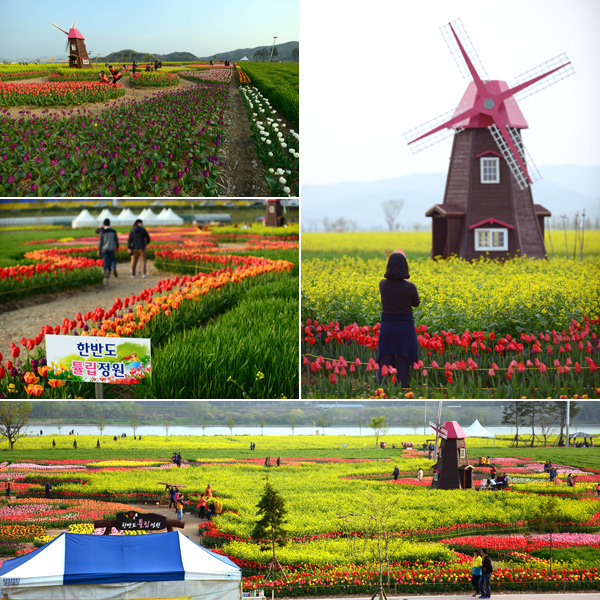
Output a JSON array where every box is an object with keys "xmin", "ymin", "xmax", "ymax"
[{"xmin": 0, "ymin": 435, "xmax": 600, "ymax": 597}]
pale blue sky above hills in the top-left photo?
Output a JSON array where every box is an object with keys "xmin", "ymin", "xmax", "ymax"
[{"xmin": 0, "ymin": 0, "xmax": 299, "ymax": 60}]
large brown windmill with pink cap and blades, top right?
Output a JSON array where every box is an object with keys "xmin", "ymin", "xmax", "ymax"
[{"xmin": 404, "ymin": 19, "xmax": 575, "ymax": 260}]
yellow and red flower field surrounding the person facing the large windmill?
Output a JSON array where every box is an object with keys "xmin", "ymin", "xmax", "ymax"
[{"xmin": 301, "ymin": 231, "xmax": 600, "ymax": 398}]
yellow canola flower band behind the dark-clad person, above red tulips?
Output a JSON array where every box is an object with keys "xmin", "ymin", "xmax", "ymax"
[{"xmin": 302, "ymin": 254, "xmax": 600, "ymax": 335}]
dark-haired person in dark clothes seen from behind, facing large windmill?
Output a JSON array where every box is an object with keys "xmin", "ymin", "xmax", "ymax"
[{"xmin": 375, "ymin": 250, "xmax": 421, "ymax": 388}]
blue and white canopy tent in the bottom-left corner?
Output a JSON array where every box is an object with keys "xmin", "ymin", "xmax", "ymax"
[{"xmin": 0, "ymin": 532, "xmax": 242, "ymax": 600}]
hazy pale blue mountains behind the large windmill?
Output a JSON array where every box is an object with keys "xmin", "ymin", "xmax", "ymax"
[{"xmin": 300, "ymin": 165, "xmax": 600, "ymax": 231}]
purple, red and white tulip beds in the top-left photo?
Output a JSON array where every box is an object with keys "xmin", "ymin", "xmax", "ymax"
[{"xmin": 0, "ymin": 64, "xmax": 299, "ymax": 198}]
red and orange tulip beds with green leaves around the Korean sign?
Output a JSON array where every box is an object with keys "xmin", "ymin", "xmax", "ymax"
[{"xmin": 0, "ymin": 228, "xmax": 298, "ymax": 399}]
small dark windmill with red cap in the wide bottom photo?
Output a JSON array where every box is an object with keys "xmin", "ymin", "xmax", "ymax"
[{"xmin": 430, "ymin": 421, "xmax": 473, "ymax": 490}]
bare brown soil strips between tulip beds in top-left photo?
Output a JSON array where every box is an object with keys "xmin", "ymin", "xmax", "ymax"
[{"xmin": 0, "ymin": 73, "xmax": 269, "ymax": 198}]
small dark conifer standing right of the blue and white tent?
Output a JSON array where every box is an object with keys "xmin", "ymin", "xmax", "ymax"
[{"xmin": 250, "ymin": 479, "xmax": 287, "ymax": 581}]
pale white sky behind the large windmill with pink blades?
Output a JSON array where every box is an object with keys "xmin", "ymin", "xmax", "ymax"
[{"xmin": 301, "ymin": 0, "xmax": 600, "ymax": 184}]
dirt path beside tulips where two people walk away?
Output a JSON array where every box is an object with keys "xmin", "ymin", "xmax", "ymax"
[{"xmin": 0, "ymin": 261, "xmax": 173, "ymax": 358}]
